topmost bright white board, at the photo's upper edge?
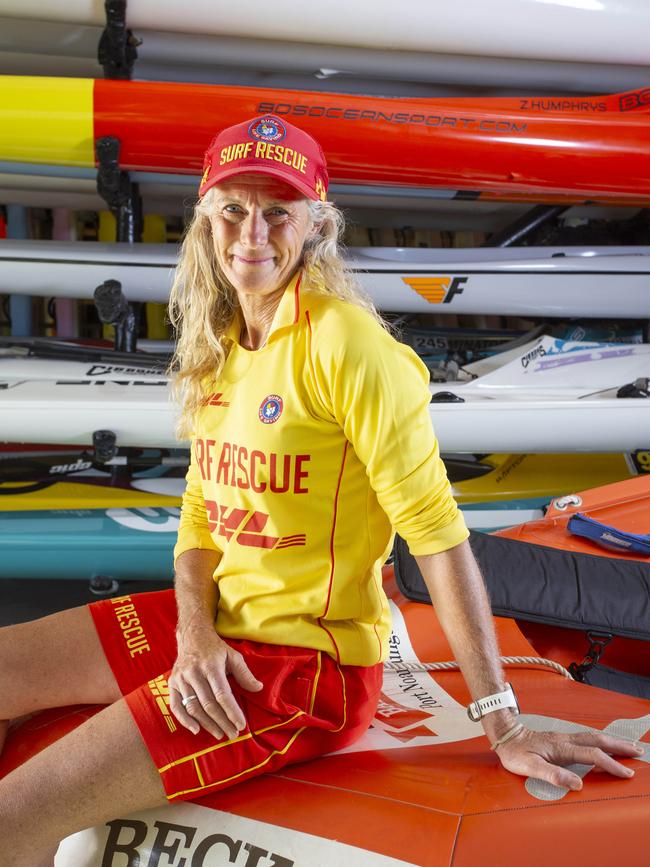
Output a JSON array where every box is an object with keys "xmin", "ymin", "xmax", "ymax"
[{"xmin": 2, "ymin": 0, "xmax": 650, "ymax": 65}]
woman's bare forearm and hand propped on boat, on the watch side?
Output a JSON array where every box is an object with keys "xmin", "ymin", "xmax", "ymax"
[{"xmin": 415, "ymin": 541, "xmax": 643, "ymax": 790}]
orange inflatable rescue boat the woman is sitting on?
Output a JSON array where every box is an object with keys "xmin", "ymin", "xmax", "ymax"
[{"xmin": 0, "ymin": 479, "xmax": 650, "ymax": 867}]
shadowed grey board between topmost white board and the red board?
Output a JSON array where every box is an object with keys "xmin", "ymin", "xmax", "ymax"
[{"xmin": 0, "ymin": 18, "xmax": 648, "ymax": 96}]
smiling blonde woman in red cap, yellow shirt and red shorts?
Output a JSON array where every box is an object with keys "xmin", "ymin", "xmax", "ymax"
[{"xmin": 0, "ymin": 117, "xmax": 639, "ymax": 867}]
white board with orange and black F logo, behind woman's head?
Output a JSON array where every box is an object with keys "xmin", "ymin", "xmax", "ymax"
[{"xmin": 0, "ymin": 240, "xmax": 650, "ymax": 318}]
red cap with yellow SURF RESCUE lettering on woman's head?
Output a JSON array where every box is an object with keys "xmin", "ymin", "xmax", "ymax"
[{"xmin": 199, "ymin": 114, "xmax": 328, "ymax": 202}]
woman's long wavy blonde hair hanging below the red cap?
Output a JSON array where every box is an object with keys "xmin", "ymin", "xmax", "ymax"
[{"xmin": 169, "ymin": 187, "xmax": 386, "ymax": 438}]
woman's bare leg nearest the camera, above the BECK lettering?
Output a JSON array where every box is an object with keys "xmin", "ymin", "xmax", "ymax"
[{"xmin": 0, "ymin": 699, "xmax": 166, "ymax": 867}]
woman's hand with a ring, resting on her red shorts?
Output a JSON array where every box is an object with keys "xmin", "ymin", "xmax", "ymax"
[{"xmin": 169, "ymin": 625, "xmax": 263, "ymax": 740}]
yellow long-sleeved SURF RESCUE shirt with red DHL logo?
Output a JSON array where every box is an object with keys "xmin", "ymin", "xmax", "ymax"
[{"xmin": 174, "ymin": 275, "xmax": 468, "ymax": 665}]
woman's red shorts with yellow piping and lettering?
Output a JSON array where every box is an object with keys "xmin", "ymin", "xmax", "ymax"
[{"xmin": 88, "ymin": 590, "xmax": 382, "ymax": 801}]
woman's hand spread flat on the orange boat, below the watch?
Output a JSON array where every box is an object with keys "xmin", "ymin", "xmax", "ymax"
[{"xmin": 496, "ymin": 728, "xmax": 644, "ymax": 792}]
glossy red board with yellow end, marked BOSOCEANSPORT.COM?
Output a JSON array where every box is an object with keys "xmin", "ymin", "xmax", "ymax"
[{"xmin": 0, "ymin": 76, "xmax": 650, "ymax": 201}]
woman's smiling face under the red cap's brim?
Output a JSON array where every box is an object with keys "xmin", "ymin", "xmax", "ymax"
[{"xmin": 210, "ymin": 173, "xmax": 316, "ymax": 296}]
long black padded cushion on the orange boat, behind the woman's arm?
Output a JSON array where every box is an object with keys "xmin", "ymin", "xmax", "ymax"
[{"xmin": 394, "ymin": 533, "xmax": 650, "ymax": 641}]
